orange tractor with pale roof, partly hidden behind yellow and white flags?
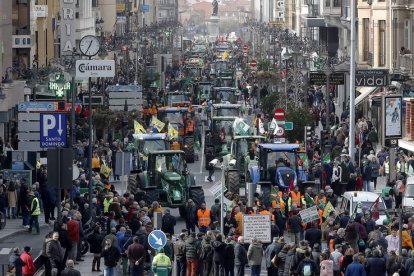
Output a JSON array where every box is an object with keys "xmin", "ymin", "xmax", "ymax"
[{"xmin": 158, "ymin": 107, "xmax": 195, "ymax": 163}]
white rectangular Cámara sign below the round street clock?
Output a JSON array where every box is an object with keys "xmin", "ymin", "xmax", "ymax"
[{"xmin": 76, "ymin": 59, "xmax": 115, "ymax": 79}]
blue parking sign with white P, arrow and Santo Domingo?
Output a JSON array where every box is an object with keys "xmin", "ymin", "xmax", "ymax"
[{"xmin": 40, "ymin": 113, "xmax": 66, "ymax": 148}]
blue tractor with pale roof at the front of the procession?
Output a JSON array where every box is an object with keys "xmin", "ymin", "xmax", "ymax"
[{"xmin": 246, "ymin": 144, "xmax": 300, "ymax": 206}]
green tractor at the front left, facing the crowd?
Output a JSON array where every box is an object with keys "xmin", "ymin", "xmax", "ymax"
[{"xmin": 130, "ymin": 150, "xmax": 204, "ymax": 216}]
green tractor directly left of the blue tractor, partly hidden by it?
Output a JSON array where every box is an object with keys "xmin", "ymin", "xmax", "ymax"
[{"xmin": 224, "ymin": 135, "xmax": 266, "ymax": 194}]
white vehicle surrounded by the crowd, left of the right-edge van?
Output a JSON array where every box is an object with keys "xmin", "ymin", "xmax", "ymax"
[{"xmin": 339, "ymin": 191, "xmax": 387, "ymax": 225}]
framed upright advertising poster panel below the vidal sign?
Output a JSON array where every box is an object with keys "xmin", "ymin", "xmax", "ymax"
[{"xmin": 382, "ymin": 95, "xmax": 402, "ymax": 139}]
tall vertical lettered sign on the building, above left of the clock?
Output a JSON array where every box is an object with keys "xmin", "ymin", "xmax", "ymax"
[{"xmin": 60, "ymin": 0, "xmax": 76, "ymax": 55}]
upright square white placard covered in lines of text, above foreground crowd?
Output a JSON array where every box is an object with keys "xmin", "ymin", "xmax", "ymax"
[{"xmin": 243, "ymin": 215, "xmax": 272, "ymax": 243}]
